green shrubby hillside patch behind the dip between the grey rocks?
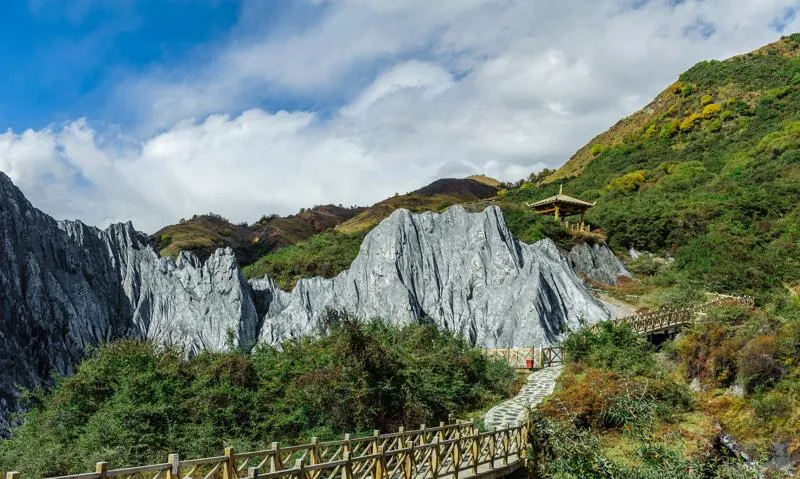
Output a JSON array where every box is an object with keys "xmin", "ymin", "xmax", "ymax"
[{"xmin": 244, "ymin": 230, "xmax": 366, "ymax": 290}]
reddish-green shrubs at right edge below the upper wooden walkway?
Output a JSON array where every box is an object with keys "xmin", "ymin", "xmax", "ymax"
[{"xmin": 675, "ymin": 295, "xmax": 800, "ymax": 456}]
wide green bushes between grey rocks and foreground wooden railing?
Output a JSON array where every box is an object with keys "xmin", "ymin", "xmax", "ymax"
[{"xmin": 0, "ymin": 313, "xmax": 516, "ymax": 477}]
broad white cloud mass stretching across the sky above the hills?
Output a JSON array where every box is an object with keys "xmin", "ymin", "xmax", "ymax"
[{"xmin": 0, "ymin": 0, "xmax": 798, "ymax": 231}]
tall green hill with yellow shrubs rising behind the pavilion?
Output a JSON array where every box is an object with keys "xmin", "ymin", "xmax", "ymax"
[{"xmin": 507, "ymin": 34, "xmax": 800, "ymax": 293}]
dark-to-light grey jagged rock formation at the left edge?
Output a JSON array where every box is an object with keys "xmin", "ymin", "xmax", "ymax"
[{"xmin": 0, "ymin": 172, "xmax": 259, "ymax": 432}]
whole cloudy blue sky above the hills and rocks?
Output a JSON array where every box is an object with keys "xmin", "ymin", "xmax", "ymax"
[{"xmin": 0, "ymin": 0, "xmax": 800, "ymax": 232}]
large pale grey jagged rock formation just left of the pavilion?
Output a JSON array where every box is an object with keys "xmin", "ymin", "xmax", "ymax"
[{"xmin": 260, "ymin": 206, "xmax": 610, "ymax": 347}]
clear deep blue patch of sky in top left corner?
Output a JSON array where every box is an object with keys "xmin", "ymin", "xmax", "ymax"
[{"xmin": 0, "ymin": 0, "xmax": 244, "ymax": 130}]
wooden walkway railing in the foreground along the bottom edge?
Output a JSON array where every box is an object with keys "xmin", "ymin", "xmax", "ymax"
[{"xmin": 5, "ymin": 421, "xmax": 527, "ymax": 479}]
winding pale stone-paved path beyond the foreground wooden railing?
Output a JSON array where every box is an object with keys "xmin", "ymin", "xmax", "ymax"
[{"xmin": 483, "ymin": 366, "xmax": 563, "ymax": 429}]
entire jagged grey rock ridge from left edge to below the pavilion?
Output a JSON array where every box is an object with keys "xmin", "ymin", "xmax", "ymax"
[{"xmin": 0, "ymin": 173, "xmax": 609, "ymax": 432}]
